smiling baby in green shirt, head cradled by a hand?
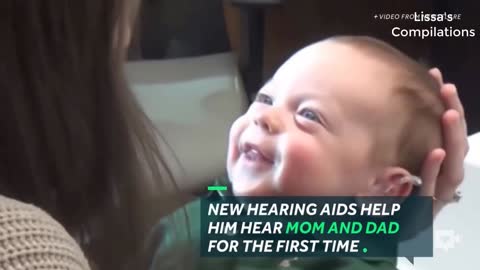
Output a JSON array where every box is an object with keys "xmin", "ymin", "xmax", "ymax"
[{"xmin": 149, "ymin": 36, "xmax": 444, "ymax": 270}]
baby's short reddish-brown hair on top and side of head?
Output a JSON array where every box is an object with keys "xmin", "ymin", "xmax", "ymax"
[{"xmin": 329, "ymin": 36, "xmax": 445, "ymax": 175}]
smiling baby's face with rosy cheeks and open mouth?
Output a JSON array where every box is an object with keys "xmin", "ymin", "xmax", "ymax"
[{"xmin": 227, "ymin": 43, "xmax": 398, "ymax": 196}]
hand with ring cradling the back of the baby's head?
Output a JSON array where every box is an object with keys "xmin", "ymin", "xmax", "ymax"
[{"xmin": 420, "ymin": 68, "xmax": 468, "ymax": 216}]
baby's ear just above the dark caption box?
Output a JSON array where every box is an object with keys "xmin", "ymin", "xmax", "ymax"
[{"xmin": 369, "ymin": 167, "xmax": 421, "ymax": 197}]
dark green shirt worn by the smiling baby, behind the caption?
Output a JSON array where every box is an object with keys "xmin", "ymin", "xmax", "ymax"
[{"xmin": 150, "ymin": 192, "xmax": 396, "ymax": 270}]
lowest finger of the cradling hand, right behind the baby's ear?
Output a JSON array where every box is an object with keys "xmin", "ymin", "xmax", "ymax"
[{"xmin": 420, "ymin": 148, "xmax": 445, "ymax": 196}]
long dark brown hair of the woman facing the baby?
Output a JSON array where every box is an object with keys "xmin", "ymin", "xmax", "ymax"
[{"xmin": 0, "ymin": 0, "xmax": 173, "ymax": 270}]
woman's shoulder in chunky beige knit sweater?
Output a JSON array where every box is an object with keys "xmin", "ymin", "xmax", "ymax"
[{"xmin": 0, "ymin": 196, "xmax": 90, "ymax": 270}]
